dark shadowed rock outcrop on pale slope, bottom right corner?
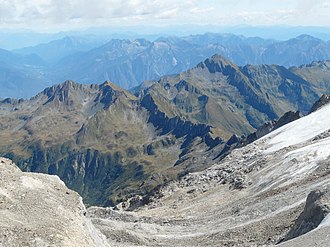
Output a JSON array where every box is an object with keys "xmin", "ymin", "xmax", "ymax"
[{"xmin": 284, "ymin": 187, "xmax": 330, "ymax": 241}]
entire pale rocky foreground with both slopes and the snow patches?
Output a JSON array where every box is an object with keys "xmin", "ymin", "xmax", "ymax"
[{"xmin": 0, "ymin": 93, "xmax": 330, "ymax": 247}]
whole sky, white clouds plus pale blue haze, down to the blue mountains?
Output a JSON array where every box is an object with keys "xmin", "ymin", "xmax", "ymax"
[{"xmin": 0, "ymin": 0, "xmax": 330, "ymax": 50}]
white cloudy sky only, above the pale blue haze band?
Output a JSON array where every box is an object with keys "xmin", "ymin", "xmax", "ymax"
[{"xmin": 0, "ymin": 0, "xmax": 330, "ymax": 31}]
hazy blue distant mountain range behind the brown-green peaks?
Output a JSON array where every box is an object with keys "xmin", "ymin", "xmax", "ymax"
[{"xmin": 0, "ymin": 33, "xmax": 330, "ymax": 98}]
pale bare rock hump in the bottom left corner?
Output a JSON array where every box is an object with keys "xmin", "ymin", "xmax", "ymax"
[{"xmin": 0, "ymin": 158, "xmax": 107, "ymax": 247}]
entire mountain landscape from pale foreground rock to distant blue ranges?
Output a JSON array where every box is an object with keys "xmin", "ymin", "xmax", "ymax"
[{"xmin": 0, "ymin": 26, "xmax": 330, "ymax": 247}]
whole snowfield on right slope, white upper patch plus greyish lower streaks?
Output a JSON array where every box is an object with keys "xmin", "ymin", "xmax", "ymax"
[{"xmin": 249, "ymin": 104, "xmax": 330, "ymax": 191}]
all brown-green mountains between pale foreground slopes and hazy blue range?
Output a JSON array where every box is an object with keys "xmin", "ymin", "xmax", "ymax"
[{"xmin": 0, "ymin": 55, "xmax": 330, "ymax": 205}]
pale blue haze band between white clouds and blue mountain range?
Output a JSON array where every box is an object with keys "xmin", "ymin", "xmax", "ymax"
[{"xmin": 0, "ymin": 24, "xmax": 330, "ymax": 50}]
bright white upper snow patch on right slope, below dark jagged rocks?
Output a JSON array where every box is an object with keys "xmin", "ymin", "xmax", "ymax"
[{"xmin": 262, "ymin": 104, "xmax": 330, "ymax": 153}]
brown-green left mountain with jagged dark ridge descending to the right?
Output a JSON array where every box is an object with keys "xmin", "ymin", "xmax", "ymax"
[{"xmin": 0, "ymin": 78, "xmax": 220, "ymax": 205}]
